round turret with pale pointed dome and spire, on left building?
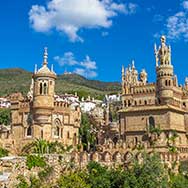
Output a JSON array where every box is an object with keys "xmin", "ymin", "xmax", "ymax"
[{"xmin": 33, "ymin": 48, "xmax": 56, "ymax": 139}]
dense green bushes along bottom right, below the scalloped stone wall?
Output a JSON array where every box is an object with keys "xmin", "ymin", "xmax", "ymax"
[{"xmin": 58, "ymin": 154, "xmax": 188, "ymax": 188}]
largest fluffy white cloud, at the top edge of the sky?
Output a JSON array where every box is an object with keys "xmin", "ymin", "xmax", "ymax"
[{"xmin": 29, "ymin": 0, "xmax": 137, "ymax": 42}]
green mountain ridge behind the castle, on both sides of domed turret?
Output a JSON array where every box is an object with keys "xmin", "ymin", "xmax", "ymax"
[{"xmin": 0, "ymin": 68, "xmax": 121, "ymax": 98}]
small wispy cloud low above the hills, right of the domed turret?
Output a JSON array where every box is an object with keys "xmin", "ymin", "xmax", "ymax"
[{"xmin": 54, "ymin": 52, "xmax": 97, "ymax": 78}]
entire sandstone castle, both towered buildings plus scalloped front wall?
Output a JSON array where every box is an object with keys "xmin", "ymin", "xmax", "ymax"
[{"xmin": 0, "ymin": 36, "xmax": 188, "ymax": 164}]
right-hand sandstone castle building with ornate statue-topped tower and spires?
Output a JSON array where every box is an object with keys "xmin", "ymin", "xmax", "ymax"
[{"xmin": 119, "ymin": 36, "xmax": 188, "ymax": 157}]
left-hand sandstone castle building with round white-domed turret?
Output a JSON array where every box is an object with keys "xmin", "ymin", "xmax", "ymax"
[{"xmin": 1, "ymin": 48, "xmax": 81, "ymax": 153}]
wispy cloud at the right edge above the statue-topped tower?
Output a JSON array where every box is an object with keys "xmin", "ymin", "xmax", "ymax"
[{"xmin": 166, "ymin": 1, "xmax": 188, "ymax": 41}]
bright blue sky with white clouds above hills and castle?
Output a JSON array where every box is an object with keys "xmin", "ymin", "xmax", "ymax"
[{"xmin": 0, "ymin": 0, "xmax": 188, "ymax": 84}]
